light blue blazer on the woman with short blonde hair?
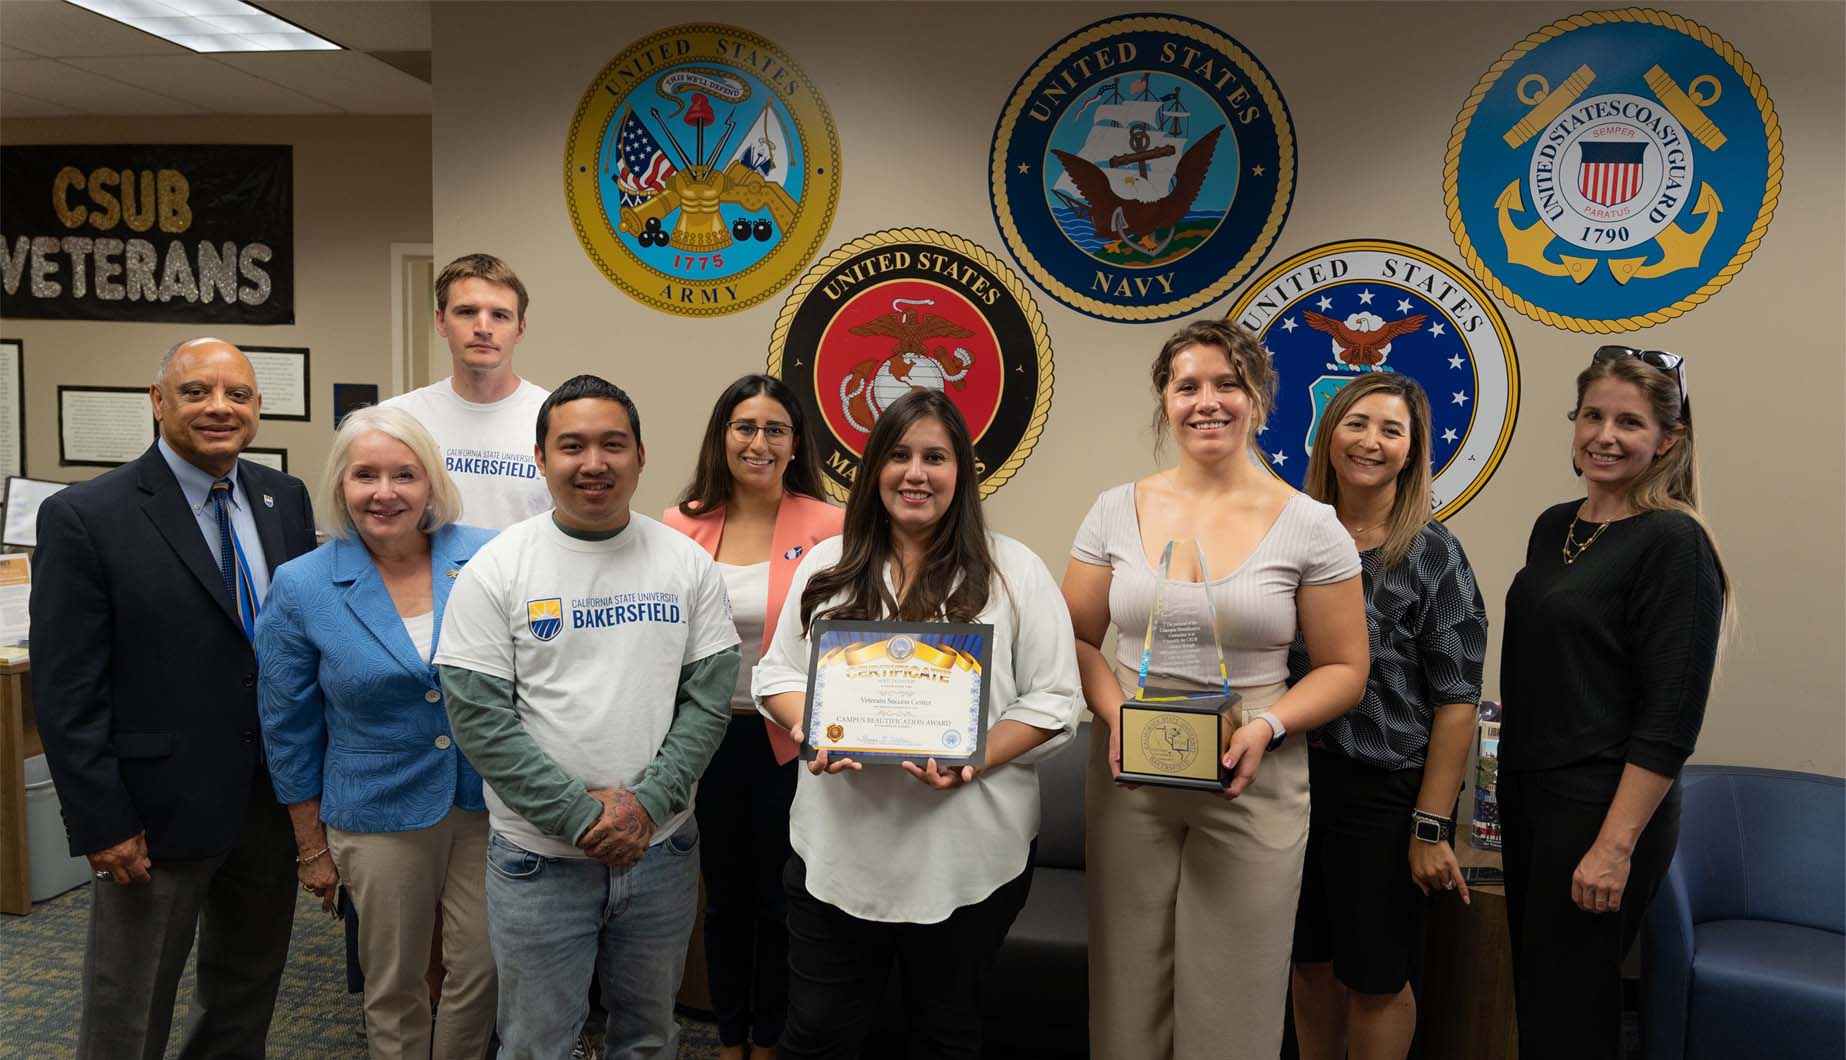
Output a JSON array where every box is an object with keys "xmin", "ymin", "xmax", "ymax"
[{"xmin": 257, "ymin": 526, "xmax": 493, "ymax": 833}]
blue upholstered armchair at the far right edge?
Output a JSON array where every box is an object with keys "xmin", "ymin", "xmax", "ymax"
[{"xmin": 1641, "ymin": 766, "xmax": 1846, "ymax": 1060}]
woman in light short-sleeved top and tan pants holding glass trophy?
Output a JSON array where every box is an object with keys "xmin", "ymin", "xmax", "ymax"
[{"xmin": 1063, "ymin": 319, "xmax": 1368, "ymax": 1060}]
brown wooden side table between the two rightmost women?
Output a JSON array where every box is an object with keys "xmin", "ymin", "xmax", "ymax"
[{"xmin": 1418, "ymin": 840, "xmax": 1519, "ymax": 1060}]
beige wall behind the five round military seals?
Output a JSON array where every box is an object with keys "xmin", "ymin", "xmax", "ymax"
[{"xmin": 434, "ymin": 4, "xmax": 1846, "ymax": 774}]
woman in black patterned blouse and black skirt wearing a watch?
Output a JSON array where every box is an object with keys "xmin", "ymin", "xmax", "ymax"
[{"xmin": 1289, "ymin": 371, "xmax": 1488, "ymax": 1060}]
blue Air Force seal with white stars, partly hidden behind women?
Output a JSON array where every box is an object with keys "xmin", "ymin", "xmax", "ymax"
[{"xmin": 1229, "ymin": 240, "xmax": 1519, "ymax": 519}]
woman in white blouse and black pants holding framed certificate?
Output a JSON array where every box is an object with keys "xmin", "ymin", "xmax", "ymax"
[{"xmin": 755, "ymin": 390, "xmax": 1080, "ymax": 1060}]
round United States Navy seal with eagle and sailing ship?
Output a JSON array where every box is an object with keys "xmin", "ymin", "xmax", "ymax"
[{"xmin": 989, "ymin": 15, "xmax": 1294, "ymax": 321}]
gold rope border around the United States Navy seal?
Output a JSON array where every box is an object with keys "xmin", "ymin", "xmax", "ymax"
[{"xmin": 988, "ymin": 15, "xmax": 1298, "ymax": 321}]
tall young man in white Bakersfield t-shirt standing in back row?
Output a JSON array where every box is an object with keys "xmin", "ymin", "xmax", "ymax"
[{"xmin": 382, "ymin": 255, "xmax": 552, "ymax": 530}]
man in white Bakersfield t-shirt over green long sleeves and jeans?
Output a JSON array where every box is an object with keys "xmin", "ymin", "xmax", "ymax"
[{"xmin": 436, "ymin": 375, "xmax": 738, "ymax": 1060}]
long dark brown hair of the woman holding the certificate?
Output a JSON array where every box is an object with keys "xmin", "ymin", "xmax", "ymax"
[{"xmin": 801, "ymin": 390, "xmax": 999, "ymax": 632}]
